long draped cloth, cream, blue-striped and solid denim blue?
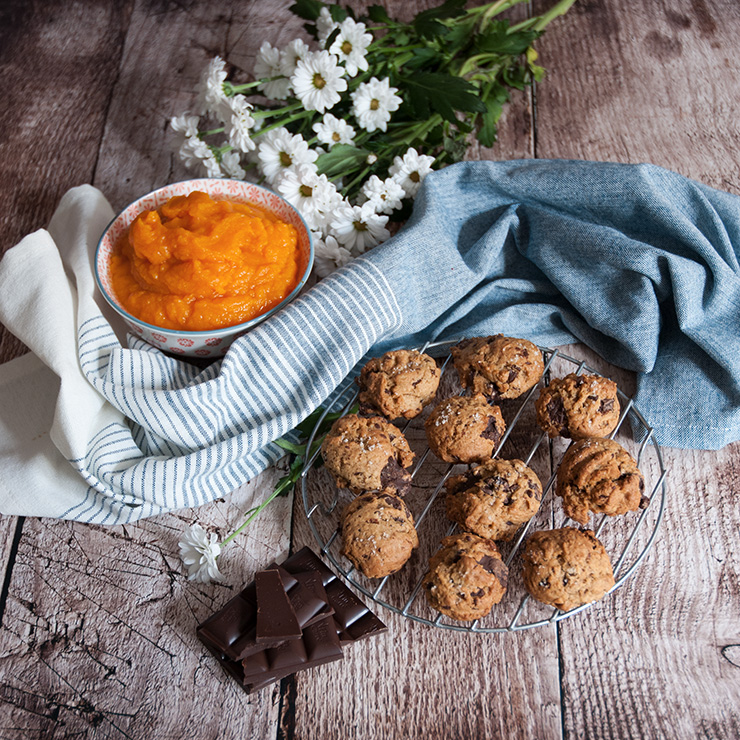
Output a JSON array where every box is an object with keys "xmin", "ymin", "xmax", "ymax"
[{"xmin": 0, "ymin": 161, "xmax": 740, "ymax": 524}]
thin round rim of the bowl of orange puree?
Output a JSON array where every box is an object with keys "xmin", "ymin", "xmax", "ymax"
[{"xmin": 93, "ymin": 177, "xmax": 314, "ymax": 338}]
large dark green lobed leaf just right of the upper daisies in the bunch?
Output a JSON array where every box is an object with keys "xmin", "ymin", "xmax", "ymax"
[{"xmin": 403, "ymin": 72, "xmax": 486, "ymax": 123}]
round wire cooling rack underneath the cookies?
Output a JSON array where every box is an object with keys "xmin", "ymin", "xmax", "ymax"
[{"xmin": 301, "ymin": 340, "xmax": 667, "ymax": 633}]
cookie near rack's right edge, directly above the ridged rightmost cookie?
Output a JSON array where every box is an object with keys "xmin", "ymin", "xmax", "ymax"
[{"xmin": 535, "ymin": 373, "xmax": 619, "ymax": 439}]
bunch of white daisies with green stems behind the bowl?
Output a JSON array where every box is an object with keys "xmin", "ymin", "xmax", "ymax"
[{"xmin": 166, "ymin": 0, "xmax": 575, "ymax": 274}]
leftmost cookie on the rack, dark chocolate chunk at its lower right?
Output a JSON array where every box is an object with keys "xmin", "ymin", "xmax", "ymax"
[{"xmin": 321, "ymin": 414, "xmax": 414, "ymax": 493}]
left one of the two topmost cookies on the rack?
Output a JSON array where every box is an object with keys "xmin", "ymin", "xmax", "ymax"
[{"xmin": 357, "ymin": 349, "xmax": 442, "ymax": 419}]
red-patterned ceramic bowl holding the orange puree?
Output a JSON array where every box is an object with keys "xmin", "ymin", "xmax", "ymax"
[{"xmin": 95, "ymin": 178, "xmax": 313, "ymax": 358}]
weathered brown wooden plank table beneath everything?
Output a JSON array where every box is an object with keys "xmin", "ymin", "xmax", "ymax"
[{"xmin": 0, "ymin": 0, "xmax": 740, "ymax": 740}]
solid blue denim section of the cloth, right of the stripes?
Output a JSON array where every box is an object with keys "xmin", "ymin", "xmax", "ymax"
[{"xmin": 366, "ymin": 160, "xmax": 740, "ymax": 449}]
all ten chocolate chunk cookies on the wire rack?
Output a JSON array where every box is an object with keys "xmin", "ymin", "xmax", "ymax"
[{"xmin": 322, "ymin": 334, "xmax": 645, "ymax": 621}]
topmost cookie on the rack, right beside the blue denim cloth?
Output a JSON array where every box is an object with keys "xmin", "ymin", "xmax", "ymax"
[{"xmin": 450, "ymin": 334, "xmax": 545, "ymax": 401}]
